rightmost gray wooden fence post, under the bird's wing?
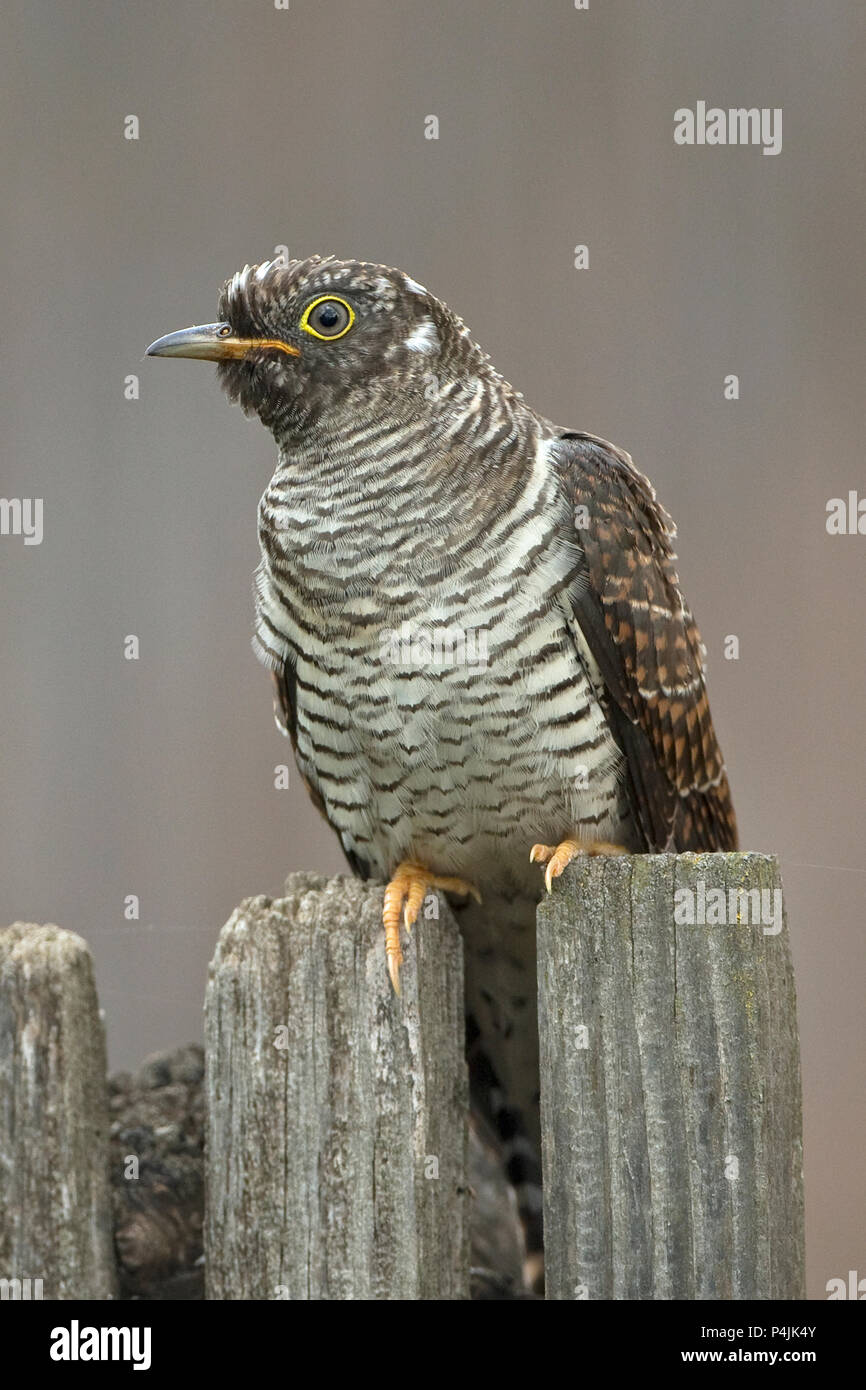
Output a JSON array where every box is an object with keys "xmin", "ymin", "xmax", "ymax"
[{"xmin": 538, "ymin": 853, "xmax": 805, "ymax": 1300}]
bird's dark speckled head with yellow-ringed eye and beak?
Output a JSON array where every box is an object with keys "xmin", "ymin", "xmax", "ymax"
[{"xmin": 147, "ymin": 256, "xmax": 467, "ymax": 438}]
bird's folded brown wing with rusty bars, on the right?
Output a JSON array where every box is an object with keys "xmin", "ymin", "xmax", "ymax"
[{"xmin": 562, "ymin": 431, "xmax": 737, "ymax": 851}]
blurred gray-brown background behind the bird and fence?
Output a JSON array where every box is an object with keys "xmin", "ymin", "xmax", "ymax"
[{"xmin": 0, "ymin": 0, "xmax": 866, "ymax": 1297}]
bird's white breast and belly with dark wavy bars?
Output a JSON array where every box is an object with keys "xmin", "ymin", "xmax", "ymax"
[{"xmin": 256, "ymin": 424, "xmax": 633, "ymax": 894}]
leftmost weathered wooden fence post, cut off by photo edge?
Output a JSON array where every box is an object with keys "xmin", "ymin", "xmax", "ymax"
[{"xmin": 0, "ymin": 922, "xmax": 115, "ymax": 1300}]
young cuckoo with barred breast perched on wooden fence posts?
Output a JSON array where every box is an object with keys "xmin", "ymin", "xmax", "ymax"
[{"xmin": 147, "ymin": 254, "xmax": 737, "ymax": 1279}]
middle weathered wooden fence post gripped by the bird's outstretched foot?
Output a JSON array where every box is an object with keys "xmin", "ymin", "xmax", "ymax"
[{"xmin": 204, "ymin": 873, "xmax": 468, "ymax": 1298}]
